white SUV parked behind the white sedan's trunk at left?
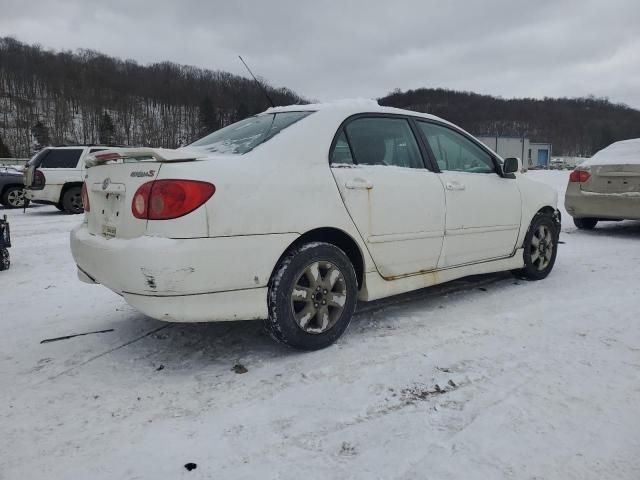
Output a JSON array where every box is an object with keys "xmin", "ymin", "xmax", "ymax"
[{"xmin": 24, "ymin": 145, "xmax": 108, "ymax": 213}]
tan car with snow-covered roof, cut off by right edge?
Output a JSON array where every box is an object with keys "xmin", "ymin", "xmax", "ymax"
[{"xmin": 565, "ymin": 138, "xmax": 640, "ymax": 229}]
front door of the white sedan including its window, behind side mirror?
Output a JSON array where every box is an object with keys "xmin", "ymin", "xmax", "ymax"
[{"xmin": 417, "ymin": 121, "xmax": 522, "ymax": 268}]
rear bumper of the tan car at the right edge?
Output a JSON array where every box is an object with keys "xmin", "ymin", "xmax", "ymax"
[{"xmin": 564, "ymin": 183, "xmax": 640, "ymax": 220}]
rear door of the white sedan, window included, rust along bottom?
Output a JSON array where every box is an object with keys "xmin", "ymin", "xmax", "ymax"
[{"xmin": 331, "ymin": 115, "xmax": 445, "ymax": 278}]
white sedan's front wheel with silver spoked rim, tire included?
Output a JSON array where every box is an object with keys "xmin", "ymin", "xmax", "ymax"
[{"xmin": 515, "ymin": 212, "xmax": 560, "ymax": 280}]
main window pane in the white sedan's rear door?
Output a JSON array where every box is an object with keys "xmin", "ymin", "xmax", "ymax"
[{"xmin": 346, "ymin": 117, "xmax": 424, "ymax": 168}]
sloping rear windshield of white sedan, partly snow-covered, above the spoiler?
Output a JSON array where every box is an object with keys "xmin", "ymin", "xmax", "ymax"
[{"xmin": 189, "ymin": 112, "xmax": 313, "ymax": 155}]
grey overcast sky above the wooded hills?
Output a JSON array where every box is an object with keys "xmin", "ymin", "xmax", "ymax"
[{"xmin": 0, "ymin": 0, "xmax": 640, "ymax": 108}]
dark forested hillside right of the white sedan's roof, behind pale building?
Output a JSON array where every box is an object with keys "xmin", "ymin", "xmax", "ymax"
[{"xmin": 379, "ymin": 89, "xmax": 640, "ymax": 156}]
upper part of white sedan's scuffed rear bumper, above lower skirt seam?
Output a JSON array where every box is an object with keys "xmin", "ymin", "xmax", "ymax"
[{"xmin": 71, "ymin": 224, "xmax": 298, "ymax": 297}]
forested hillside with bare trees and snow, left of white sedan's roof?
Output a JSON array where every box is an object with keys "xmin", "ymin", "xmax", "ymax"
[{"xmin": 0, "ymin": 38, "xmax": 303, "ymax": 157}]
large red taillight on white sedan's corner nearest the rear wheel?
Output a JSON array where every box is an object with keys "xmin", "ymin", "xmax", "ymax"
[{"xmin": 131, "ymin": 180, "xmax": 216, "ymax": 220}]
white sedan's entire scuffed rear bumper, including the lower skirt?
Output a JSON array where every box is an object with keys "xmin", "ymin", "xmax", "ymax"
[{"xmin": 71, "ymin": 224, "xmax": 298, "ymax": 322}]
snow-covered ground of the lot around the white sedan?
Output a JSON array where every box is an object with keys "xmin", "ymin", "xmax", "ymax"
[{"xmin": 0, "ymin": 171, "xmax": 640, "ymax": 480}]
